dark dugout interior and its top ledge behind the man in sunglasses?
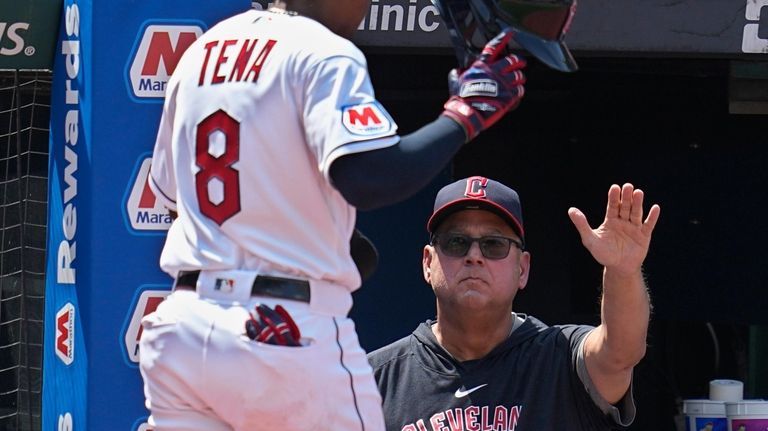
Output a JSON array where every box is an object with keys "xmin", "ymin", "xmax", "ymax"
[{"xmin": 353, "ymin": 1, "xmax": 768, "ymax": 430}]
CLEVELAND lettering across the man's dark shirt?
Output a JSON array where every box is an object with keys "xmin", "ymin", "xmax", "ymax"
[{"xmin": 400, "ymin": 406, "xmax": 523, "ymax": 431}]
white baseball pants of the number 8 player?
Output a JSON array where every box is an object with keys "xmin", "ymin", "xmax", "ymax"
[{"xmin": 139, "ymin": 290, "xmax": 384, "ymax": 431}]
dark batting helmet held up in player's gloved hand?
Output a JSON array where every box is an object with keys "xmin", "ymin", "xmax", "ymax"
[{"xmin": 432, "ymin": 0, "xmax": 578, "ymax": 72}]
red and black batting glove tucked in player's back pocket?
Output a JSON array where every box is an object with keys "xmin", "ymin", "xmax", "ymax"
[{"xmin": 245, "ymin": 304, "xmax": 301, "ymax": 346}]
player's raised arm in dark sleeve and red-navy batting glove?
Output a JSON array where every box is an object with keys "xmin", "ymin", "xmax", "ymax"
[{"xmin": 330, "ymin": 30, "xmax": 525, "ymax": 209}]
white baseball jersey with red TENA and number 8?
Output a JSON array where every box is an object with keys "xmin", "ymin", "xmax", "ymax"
[{"xmin": 150, "ymin": 10, "xmax": 399, "ymax": 290}]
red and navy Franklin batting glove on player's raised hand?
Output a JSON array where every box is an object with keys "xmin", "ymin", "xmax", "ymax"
[{"xmin": 442, "ymin": 28, "xmax": 526, "ymax": 141}]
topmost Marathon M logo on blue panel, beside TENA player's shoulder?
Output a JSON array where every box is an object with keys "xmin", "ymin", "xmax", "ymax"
[{"xmin": 128, "ymin": 24, "xmax": 203, "ymax": 98}]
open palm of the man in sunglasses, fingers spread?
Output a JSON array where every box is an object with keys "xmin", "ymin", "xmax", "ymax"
[{"xmin": 568, "ymin": 183, "xmax": 661, "ymax": 274}]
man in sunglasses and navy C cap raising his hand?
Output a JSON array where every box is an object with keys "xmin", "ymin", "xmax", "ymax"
[{"xmin": 369, "ymin": 176, "xmax": 661, "ymax": 431}]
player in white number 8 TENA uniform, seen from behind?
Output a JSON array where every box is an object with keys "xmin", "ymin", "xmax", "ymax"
[{"xmin": 140, "ymin": 0, "xmax": 525, "ymax": 431}]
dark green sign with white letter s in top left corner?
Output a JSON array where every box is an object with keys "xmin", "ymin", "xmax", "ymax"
[{"xmin": 0, "ymin": 0, "xmax": 62, "ymax": 70}]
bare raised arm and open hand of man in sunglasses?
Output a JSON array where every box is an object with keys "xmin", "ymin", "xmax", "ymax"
[{"xmin": 568, "ymin": 183, "xmax": 660, "ymax": 403}]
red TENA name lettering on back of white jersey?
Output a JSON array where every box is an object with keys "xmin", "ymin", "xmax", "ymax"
[{"xmin": 198, "ymin": 39, "xmax": 277, "ymax": 85}]
